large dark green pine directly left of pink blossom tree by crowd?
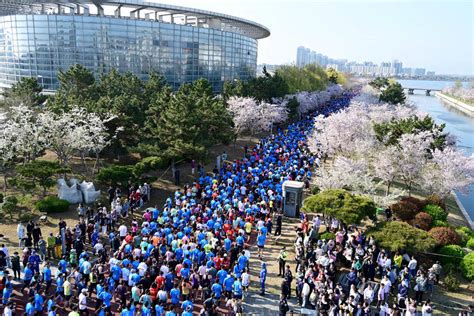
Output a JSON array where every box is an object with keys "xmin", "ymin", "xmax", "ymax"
[{"xmin": 147, "ymin": 79, "xmax": 234, "ymax": 162}]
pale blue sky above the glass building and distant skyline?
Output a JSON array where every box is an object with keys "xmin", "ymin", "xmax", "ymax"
[{"xmin": 157, "ymin": 0, "xmax": 474, "ymax": 75}]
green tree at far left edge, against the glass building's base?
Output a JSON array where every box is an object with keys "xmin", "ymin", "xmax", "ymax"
[{"xmin": 2, "ymin": 77, "xmax": 47, "ymax": 107}]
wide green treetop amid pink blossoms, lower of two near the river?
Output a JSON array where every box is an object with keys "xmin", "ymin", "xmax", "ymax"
[{"xmin": 373, "ymin": 115, "xmax": 448, "ymax": 150}]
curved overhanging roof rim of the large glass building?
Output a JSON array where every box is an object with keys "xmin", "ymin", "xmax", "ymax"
[{"xmin": 0, "ymin": 0, "xmax": 270, "ymax": 39}]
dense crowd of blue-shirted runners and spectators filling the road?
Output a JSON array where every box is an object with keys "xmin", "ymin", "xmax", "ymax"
[{"xmin": 0, "ymin": 87, "xmax": 456, "ymax": 316}]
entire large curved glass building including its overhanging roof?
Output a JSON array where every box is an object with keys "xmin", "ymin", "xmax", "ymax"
[{"xmin": 0, "ymin": 0, "xmax": 270, "ymax": 91}]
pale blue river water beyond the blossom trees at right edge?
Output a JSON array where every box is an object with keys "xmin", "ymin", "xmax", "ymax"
[{"xmin": 399, "ymin": 80, "xmax": 474, "ymax": 225}]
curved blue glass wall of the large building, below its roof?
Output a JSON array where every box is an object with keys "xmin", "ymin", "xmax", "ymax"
[{"xmin": 0, "ymin": 14, "xmax": 257, "ymax": 91}]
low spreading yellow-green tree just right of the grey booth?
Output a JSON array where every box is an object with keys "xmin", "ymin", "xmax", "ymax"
[{"xmin": 303, "ymin": 189, "xmax": 376, "ymax": 224}]
